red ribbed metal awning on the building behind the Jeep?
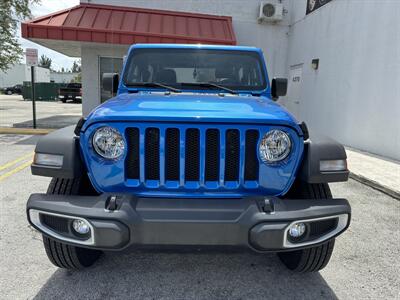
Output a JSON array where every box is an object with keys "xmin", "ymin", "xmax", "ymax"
[{"xmin": 21, "ymin": 4, "xmax": 236, "ymax": 45}]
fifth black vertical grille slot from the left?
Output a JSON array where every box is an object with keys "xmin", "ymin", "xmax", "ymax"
[{"xmin": 204, "ymin": 129, "xmax": 220, "ymax": 181}]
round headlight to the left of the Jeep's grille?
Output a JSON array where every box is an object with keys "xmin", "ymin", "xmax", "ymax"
[{"xmin": 93, "ymin": 127, "xmax": 125, "ymax": 159}]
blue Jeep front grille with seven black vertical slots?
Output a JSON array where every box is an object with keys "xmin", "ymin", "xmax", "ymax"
[{"xmin": 125, "ymin": 126, "xmax": 259, "ymax": 189}]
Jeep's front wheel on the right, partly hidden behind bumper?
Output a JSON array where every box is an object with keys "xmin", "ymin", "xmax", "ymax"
[{"xmin": 278, "ymin": 182, "xmax": 335, "ymax": 273}]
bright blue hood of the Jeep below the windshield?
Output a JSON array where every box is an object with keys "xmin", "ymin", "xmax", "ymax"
[{"xmin": 82, "ymin": 92, "xmax": 301, "ymax": 133}]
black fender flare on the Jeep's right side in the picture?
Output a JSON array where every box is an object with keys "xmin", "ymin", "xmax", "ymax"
[{"xmin": 299, "ymin": 133, "xmax": 349, "ymax": 183}]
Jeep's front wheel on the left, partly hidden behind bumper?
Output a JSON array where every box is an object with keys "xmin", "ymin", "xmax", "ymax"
[{"xmin": 43, "ymin": 178, "xmax": 102, "ymax": 270}]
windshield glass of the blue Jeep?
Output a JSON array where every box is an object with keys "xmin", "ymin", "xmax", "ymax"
[{"xmin": 123, "ymin": 49, "xmax": 267, "ymax": 91}]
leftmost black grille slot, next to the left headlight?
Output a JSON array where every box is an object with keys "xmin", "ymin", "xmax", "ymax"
[{"xmin": 125, "ymin": 128, "xmax": 140, "ymax": 179}]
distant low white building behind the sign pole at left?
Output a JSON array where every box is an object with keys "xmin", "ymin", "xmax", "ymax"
[{"xmin": 0, "ymin": 64, "xmax": 50, "ymax": 88}]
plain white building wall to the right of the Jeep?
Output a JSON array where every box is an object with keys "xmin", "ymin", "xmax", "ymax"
[{"xmin": 284, "ymin": 0, "xmax": 400, "ymax": 160}]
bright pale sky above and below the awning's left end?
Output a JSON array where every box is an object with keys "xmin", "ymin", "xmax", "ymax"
[{"xmin": 17, "ymin": 0, "xmax": 79, "ymax": 71}]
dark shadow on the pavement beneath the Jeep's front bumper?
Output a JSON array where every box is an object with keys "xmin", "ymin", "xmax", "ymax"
[{"xmin": 35, "ymin": 251, "xmax": 337, "ymax": 299}]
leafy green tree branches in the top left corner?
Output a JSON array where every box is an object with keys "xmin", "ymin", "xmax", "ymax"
[{"xmin": 0, "ymin": 0, "xmax": 40, "ymax": 71}]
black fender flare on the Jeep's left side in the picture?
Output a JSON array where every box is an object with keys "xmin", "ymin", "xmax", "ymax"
[{"xmin": 31, "ymin": 126, "xmax": 84, "ymax": 178}]
